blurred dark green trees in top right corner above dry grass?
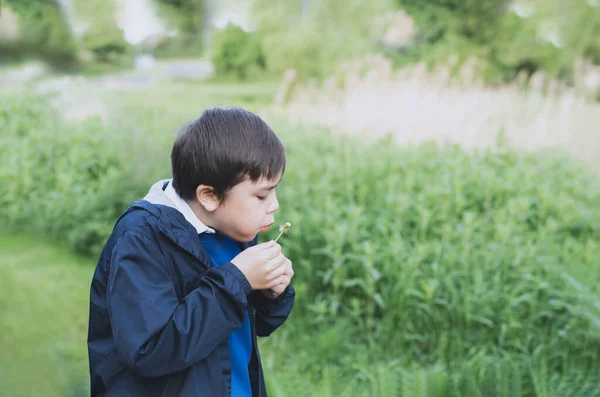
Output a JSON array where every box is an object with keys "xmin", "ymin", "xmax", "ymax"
[{"xmin": 393, "ymin": 0, "xmax": 600, "ymax": 83}]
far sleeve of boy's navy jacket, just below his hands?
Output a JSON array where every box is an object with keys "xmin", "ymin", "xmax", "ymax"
[{"xmin": 250, "ymin": 284, "xmax": 296, "ymax": 336}]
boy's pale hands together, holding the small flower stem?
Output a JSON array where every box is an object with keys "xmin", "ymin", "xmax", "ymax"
[{"xmin": 231, "ymin": 241, "xmax": 287, "ymax": 290}]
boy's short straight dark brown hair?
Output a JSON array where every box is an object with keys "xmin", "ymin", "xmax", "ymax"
[{"xmin": 171, "ymin": 108, "xmax": 285, "ymax": 200}]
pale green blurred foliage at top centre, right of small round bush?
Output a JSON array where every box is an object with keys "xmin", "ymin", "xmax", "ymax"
[{"xmin": 253, "ymin": 0, "xmax": 392, "ymax": 79}]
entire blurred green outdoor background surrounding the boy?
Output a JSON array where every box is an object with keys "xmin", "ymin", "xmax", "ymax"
[{"xmin": 0, "ymin": 0, "xmax": 600, "ymax": 397}]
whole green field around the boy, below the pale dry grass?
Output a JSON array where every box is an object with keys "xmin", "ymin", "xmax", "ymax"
[{"xmin": 0, "ymin": 78, "xmax": 600, "ymax": 397}]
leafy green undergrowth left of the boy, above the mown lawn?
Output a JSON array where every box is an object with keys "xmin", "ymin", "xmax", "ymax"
[{"xmin": 0, "ymin": 96, "xmax": 152, "ymax": 254}]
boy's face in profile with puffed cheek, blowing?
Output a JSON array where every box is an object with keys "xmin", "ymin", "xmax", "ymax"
[{"xmin": 212, "ymin": 178, "xmax": 281, "ymax": 242}]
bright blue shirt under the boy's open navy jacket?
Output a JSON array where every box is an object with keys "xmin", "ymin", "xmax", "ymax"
[{"xmin": 199, "ymin": 233, "xmax": 252, "ymax": 397}]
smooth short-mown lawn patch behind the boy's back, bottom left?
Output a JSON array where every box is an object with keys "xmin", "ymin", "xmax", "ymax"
[{"xmin": 0, "ymin": 235, "xmax": 94, "ymax": 397}]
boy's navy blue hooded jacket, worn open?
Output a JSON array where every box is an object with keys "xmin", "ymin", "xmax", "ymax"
[{"xmin": 88, "ymin": 196, "xmax": 295, "ymax": 397}]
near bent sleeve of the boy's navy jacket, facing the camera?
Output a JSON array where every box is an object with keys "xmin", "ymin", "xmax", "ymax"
[{"xmin": 107, "ymin": 227, "xmax": 252, "ymax": 377}]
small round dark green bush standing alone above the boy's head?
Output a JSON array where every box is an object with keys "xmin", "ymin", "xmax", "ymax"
[{"xmin": 212, "ymin": 23, "xmax": 265, "ymax": 80}]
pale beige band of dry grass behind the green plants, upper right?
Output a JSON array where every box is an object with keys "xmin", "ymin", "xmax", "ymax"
[{"xmin": 275, "ymin": 56, "xmax": 600, "ymax": 171}]
